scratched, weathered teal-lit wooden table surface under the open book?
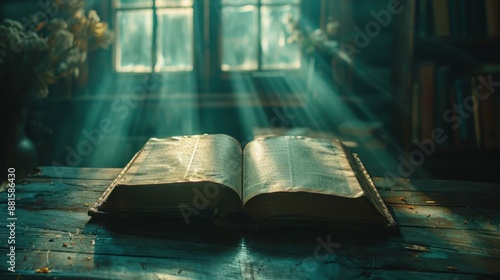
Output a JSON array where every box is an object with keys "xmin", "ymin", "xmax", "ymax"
[{"xmin": 0, "ymin": 167, "xmax": 500, "ymax": 279}]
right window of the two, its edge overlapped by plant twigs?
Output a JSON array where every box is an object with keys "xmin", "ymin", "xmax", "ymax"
[{"xmin": 221, "ymin": 0, "xmax": 300, "ymax": 71}]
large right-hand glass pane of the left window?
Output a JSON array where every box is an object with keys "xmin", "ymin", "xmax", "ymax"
[{"xmin": 155, "ymin": 8, "xmax": 193, "ymax": 71}]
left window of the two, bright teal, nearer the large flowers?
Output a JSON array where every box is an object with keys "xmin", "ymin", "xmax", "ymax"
[{"xmin": 115, "ymin": 0, "xmax": 193, "ymax": 73}]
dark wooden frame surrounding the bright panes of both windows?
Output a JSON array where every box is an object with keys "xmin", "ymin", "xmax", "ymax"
[{"xmin": 109, "ymin": 0, "xmax": 315, "ymax": 94}]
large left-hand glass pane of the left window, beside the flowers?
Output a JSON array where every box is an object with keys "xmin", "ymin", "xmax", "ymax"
[{"xmin": 116, "ymin": 10, "xmax": 153, "ymax": 72}]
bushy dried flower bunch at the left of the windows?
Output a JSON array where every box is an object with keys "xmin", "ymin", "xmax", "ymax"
[{"xmin": 0, "ymin": 0, "xmax": 113, "ymax": 103}]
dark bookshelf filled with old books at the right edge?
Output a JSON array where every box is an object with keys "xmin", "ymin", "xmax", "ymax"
[{"xmin": 394, "ymin": 0, "xmax": 500, "ymax": 179}]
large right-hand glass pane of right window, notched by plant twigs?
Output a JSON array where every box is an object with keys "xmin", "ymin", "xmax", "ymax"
[{"xmin": 261, "ymin": 5, "xmax": 300, "ymax": 69}]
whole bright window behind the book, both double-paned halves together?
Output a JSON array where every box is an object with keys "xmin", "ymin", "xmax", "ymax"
[{"xmin": 114, "ymin": 0, "xmax": 300, "ymax": 73}]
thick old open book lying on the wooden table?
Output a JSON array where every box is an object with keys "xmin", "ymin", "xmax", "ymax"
[{"xmin": 89, "ymin": 134, "xmax": 396, "ymax": 229}]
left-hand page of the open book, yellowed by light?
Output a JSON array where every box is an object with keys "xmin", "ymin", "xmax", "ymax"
[{"xmin": 119, "ymin": 134, "xmax": 242, "ymax": 198}]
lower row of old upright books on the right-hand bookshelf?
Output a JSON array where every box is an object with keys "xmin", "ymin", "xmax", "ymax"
[{"xmin": 411, "ymin": 62, "xmax": 500, "ymax": 149}]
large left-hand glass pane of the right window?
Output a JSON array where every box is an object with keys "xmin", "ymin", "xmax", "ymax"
[{"xmin": 222, "ymin": 6, "xmax": 258, "ymax": 71}]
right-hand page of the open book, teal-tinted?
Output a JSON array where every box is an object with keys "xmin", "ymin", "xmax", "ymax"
[{"xmin": 243, "ymin": 136, "xmax": 363, "ymax": 203}]
